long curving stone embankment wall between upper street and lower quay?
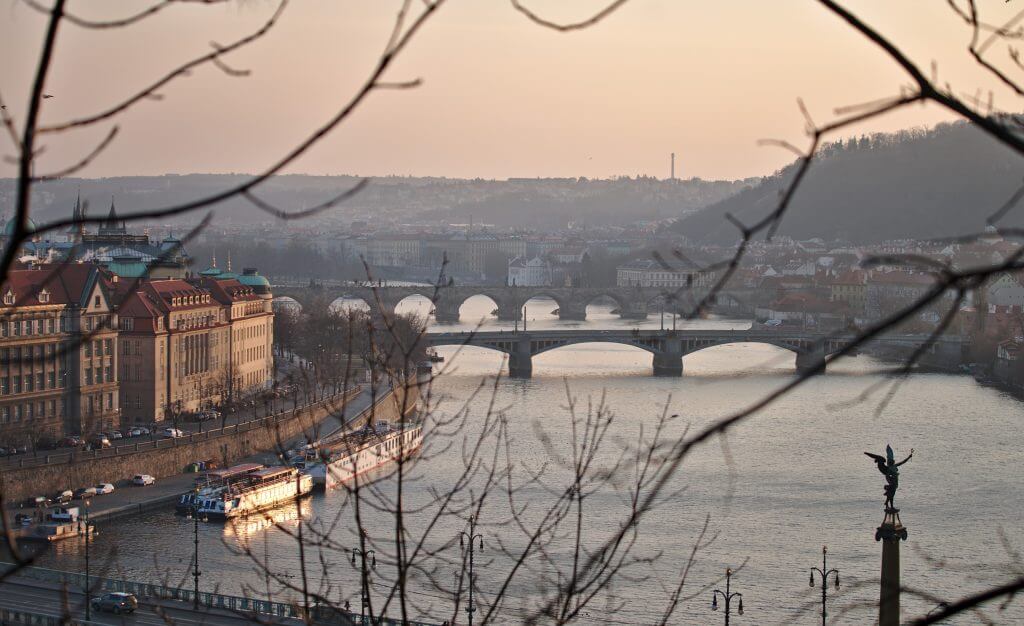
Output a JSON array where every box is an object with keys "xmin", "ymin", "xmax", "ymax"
[{"xmin": 0, "ymin": 384, "xmax": 419, "ymax": 503}]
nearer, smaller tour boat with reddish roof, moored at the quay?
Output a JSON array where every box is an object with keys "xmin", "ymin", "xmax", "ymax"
[{"xmin": 197, "ymin": 467, "xmax": 313, "ymax": 519}]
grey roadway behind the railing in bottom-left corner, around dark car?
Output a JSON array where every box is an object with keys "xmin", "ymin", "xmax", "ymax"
[{"xmin": 0, "ymin": 576, "xmax": 302, "ymax": 626}]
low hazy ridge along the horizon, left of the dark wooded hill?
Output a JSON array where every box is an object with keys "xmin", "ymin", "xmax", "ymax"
[{"xmin": 0, "ymin": 174, "xmax": 749, "ymax": 228}]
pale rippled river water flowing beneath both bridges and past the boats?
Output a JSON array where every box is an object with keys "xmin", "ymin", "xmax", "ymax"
[{"xmin": 32, "ymin": 297, "xmax": 1024, "ymax": 624}]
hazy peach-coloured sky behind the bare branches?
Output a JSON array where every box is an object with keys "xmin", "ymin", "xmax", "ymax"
[{"xmin": 0, "ymin": 0, "xmax": 1020, "ymax": 178}]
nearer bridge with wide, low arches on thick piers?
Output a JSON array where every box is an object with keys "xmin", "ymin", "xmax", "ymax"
[{"xmin": 426, "ymin": 330, "xmax": 963, "ymax": 378}]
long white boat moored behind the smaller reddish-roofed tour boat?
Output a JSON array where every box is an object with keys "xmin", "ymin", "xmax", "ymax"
[{"xmin": 292, "ymin": 422, "xmax": 423, "ymax": 489}]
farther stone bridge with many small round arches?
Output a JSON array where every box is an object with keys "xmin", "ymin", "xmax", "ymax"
[{"xmin": 273, "ymin": 285, "xmax": 720, "ymax": 323}]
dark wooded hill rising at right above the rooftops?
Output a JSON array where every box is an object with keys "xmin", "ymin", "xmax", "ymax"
[{"xmin": 672, "ymin": 123, "xmax": 1024, "ymax": 243}]
